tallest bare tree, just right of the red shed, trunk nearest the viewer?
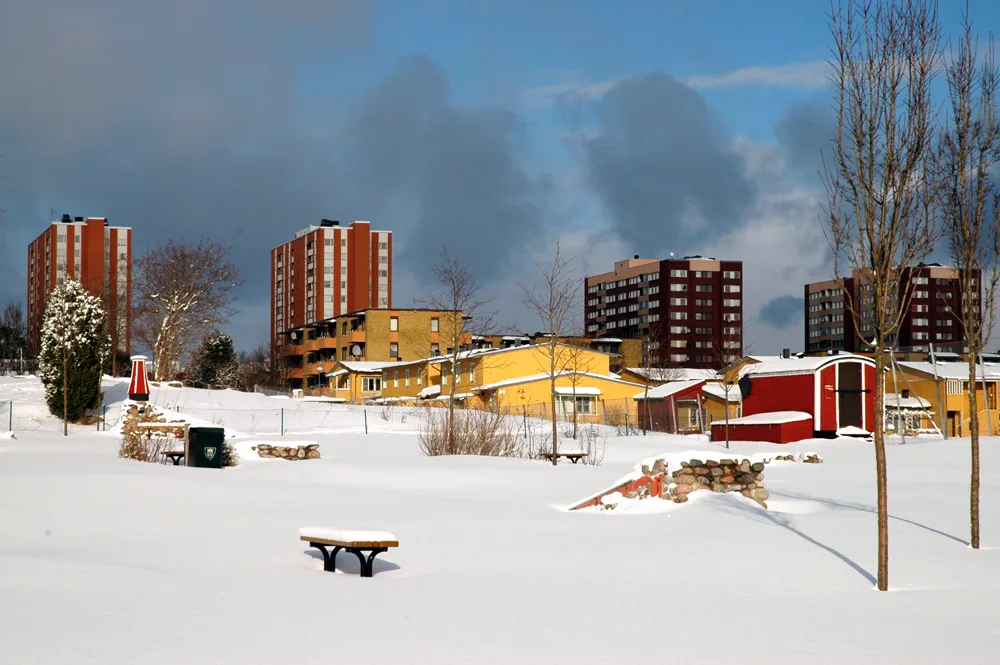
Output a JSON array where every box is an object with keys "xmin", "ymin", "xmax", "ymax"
[{"xmin": 823, "ymin": 0, "xmax": 940, "ymax": 591}]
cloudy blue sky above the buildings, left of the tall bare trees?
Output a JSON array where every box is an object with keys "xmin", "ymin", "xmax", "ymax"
[{"xmin": 0, "ymin": 0, "xmax": 1000, "ymax": 352}]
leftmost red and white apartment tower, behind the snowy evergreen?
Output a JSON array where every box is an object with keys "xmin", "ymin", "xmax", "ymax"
[{"xmin": 27, "ymin": 215, "xmax": 132, "ymax": 355}]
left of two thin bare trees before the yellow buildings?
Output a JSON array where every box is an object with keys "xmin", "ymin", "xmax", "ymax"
[{"xmin": 418, "ymin": 246, "xmax": 493, "ymax": 455}]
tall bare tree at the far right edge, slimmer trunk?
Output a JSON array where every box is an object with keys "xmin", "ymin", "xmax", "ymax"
[{"xmin": 938, "ymin": 5, "xmax": 1000, "ymax": 549}]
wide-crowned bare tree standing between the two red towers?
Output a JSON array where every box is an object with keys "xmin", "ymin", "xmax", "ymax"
[{"xmin": 133, "ymin": 239, "xmax": 243, "ymax": 381}]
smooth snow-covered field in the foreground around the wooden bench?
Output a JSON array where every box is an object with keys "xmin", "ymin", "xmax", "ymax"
[{"xmin": 0, "ymin": 376, "xmax": 1000, "ymax": 665}]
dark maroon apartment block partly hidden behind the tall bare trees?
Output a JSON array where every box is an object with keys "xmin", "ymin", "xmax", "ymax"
[{"xmin": 804, "ymin": 263, "xmax": 982, "ymax": 353}]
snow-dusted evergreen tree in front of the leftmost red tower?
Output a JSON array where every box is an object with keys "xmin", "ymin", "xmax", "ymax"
[{"xmin": 38, "ymin": 280, "xmax": 111, "ymax": 434}]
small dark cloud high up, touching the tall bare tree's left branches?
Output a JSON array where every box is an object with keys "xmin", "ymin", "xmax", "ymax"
[{"xmin": 774, "ymin": 97, "xmax": 837, "ymax": 180}]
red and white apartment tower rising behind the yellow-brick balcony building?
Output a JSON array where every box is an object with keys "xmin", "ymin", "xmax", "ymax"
[{"xmin": 271, "ymin": 219, "xmax": 392, "ymax": 346}]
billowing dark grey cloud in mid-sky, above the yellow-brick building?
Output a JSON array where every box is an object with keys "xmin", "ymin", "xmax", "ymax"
[{"xmin": 341, "ymin": 56, "xmax": 552, "ymax": 278}]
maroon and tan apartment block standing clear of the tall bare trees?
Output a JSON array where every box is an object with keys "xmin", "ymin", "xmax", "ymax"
[{"xmin": 584, "ymin": 255, "xmax": 743, "ymax": 368}]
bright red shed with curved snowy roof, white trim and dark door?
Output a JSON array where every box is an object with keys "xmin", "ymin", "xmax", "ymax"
[{"xmin": 730, "ymin": 353, "xmax": 875, "ymax": 438}]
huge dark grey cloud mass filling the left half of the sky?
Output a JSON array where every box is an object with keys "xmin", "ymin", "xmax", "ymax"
[{"xmin": 0, "ymin": 0, "xmax": 548, "ymax": 346}]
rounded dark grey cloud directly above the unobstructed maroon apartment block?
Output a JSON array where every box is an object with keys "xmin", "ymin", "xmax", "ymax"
[{"xmin": 585, "ymin": 72, "xmax": 756, "ymax": 254}]
